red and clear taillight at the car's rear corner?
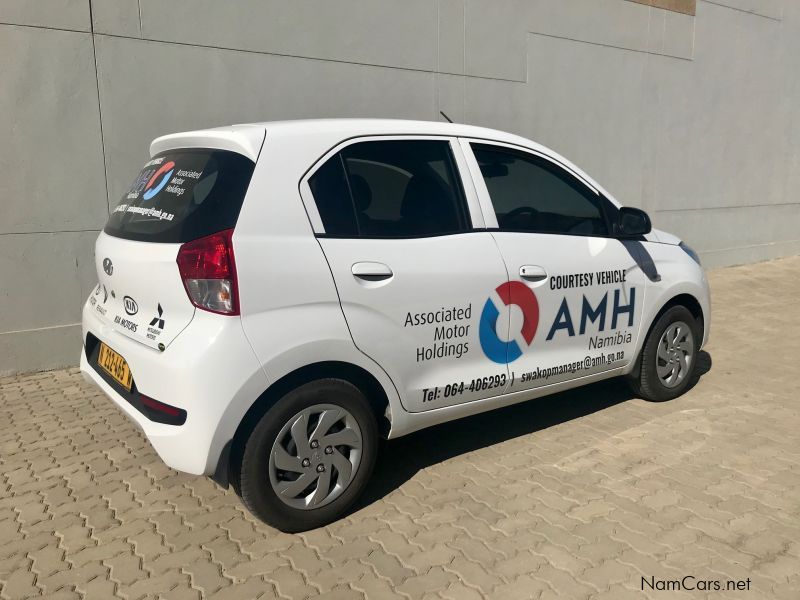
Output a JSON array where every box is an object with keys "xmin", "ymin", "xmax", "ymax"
[{"xmin": 178, "ymin": 229, "xmax": 239, "ymax": 315}]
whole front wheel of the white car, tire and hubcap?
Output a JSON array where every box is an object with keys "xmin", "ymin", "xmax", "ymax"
[{"xmin": 629, "ymin": 306, "xmax": 701, "ymax": 402}]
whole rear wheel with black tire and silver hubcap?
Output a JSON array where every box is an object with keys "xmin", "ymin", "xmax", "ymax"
[{"xmin": 238, "ymin": 379, "xmax": 378, "ymax": 532}]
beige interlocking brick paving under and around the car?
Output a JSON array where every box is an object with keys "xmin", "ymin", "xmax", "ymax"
[{"xmin": 0, "ymin": 258, "xmax": 800, "ymax": 600}]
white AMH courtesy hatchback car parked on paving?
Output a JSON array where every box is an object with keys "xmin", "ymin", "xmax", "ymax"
[{"xmin": 81, "ymin": 119, "xmax": 710, "ymax": 531}]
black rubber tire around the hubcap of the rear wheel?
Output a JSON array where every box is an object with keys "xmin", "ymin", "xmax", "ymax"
[{"xmin": 234, "ymin": 379, "xmax": 378, "ymax": 533}]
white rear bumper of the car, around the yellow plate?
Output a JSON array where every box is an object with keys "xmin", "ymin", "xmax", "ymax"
[{"xmin": 81, "ymin": 308, "xmax": 268, "ymax": 475}]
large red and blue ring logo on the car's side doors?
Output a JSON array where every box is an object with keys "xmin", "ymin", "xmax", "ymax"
[{"xmin": 479, "ymin": 281, "xmax": 539, "ymax": 365}]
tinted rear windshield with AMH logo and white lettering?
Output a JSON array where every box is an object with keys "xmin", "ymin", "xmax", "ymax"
[{"xmin": 105, "ymin": 149, "xmax": 255, "ymax": 243}]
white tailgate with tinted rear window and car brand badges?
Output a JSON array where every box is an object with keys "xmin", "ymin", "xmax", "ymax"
[{"xmin": 89, "ymin": 143, "xmax": 264, "ymax": 349}]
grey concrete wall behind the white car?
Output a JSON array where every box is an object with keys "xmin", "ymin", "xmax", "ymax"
[{"xmin": 0, "ymin": 0, "xmax": 800, "ymax": 373}]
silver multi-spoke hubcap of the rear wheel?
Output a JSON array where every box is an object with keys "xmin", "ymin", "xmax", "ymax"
[{"xmin": 269, "ymin": 404, "xmax": 361, "ymax": 510}]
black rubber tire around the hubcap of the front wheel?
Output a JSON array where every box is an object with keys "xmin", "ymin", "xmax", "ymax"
[{"xmin": 628, "ymin": 306, "xmax": 703, "ymax": 402}]
